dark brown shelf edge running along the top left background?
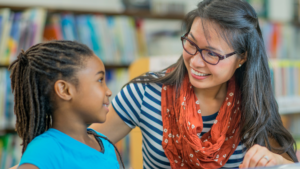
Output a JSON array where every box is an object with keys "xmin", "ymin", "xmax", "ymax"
[{"xmin": 0, "ymin": 3, "xmax": 184, "ymax": 20}]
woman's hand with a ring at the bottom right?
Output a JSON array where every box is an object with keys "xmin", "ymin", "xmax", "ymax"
[{"xmin": 239, "ymin": 144, "xmax": 293, "ymax": 168}]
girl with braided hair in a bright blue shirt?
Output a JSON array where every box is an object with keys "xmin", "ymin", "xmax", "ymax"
[{"xmin": 9, "ymin": 41, "xmax": 124, "ymax": 169}]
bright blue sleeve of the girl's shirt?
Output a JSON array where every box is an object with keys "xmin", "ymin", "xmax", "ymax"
[{"xmin": 19, "ymin": 137, "xmax": 58, "ymax": 169}]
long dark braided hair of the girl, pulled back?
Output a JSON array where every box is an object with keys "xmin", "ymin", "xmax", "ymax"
[{"xmin": 9, "ymin": 40, "xmax": 124, "ymax": 167}]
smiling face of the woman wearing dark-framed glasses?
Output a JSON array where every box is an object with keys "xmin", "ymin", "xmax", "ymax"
[{"xmin": 183, "ymin": 18, "xmax": 244, "ymax": 89}]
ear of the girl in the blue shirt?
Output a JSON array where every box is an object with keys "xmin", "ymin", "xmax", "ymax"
[{"xmin": 54, "ymin": 80, "xmax": 75, "ymax": 101}]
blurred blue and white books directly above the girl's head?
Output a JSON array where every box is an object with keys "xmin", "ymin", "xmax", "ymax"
[{"xmin": 44, "ymin": 13, "xmax": 138, "ymax": 64}]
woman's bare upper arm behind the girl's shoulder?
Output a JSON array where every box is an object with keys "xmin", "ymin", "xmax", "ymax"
[{"xmin": 90, "ymin": 105, "xmax": 131, "ymax": 143}]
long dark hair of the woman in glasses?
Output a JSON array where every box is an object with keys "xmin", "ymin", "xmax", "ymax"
[{"xmin": 129, "ymin": 0, "xmax": 298, "ymax": 162}]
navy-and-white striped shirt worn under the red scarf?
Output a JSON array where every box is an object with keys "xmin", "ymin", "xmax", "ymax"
[{"xmin": 112, "ymin": 83, "xmax": 246, "ymax": 169}]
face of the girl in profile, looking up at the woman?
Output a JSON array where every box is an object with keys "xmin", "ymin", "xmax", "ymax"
[{"xmin": 72, "ymin": 56, "xmax": 112, "ymax": 124}]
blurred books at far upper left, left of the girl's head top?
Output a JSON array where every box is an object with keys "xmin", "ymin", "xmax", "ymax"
[{"xmin": 0, "ymin": 8, "xmax": 46, "ymax": 65}]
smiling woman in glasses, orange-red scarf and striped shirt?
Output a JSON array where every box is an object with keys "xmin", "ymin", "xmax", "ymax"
[{"xmin": 91, "ymin": 0, "xmax": 297, "ymax": 168}]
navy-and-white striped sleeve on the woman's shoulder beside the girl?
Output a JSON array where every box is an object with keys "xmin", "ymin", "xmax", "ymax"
[{"xmin": 112, "ymin": 83, "xmax": 145, "ymax": 128}]
